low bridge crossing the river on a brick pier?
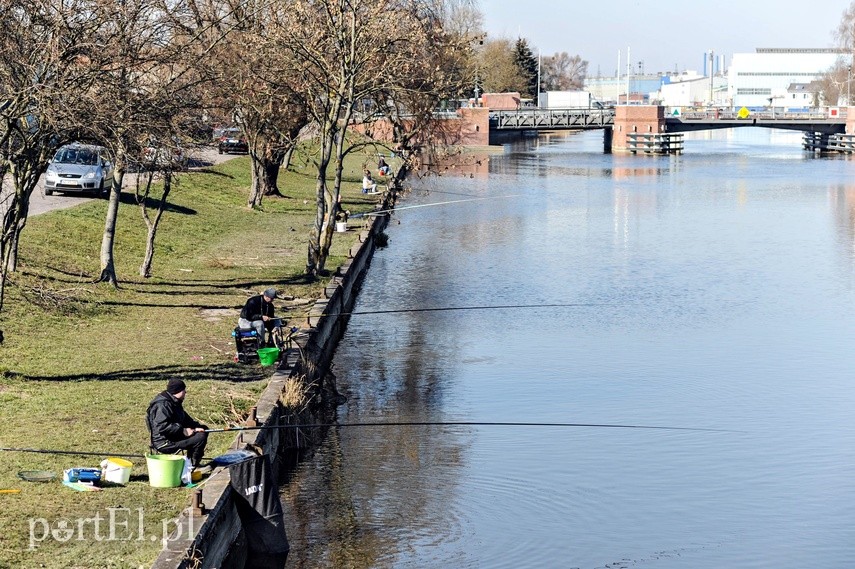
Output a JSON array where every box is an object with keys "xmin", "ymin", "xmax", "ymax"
[{"xmin": 489, "ymin": 105, "xmax": 855, "ymax": 152}]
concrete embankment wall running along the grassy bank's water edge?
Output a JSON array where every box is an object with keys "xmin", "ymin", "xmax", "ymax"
[{"xmin": 153, "ymin": 209, "xmax": 390, "ymax": 569}]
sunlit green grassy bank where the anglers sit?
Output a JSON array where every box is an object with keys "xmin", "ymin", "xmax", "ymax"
[{"xmin": 0, "ymin": 149, "xmax": 392, "ymax": 568}]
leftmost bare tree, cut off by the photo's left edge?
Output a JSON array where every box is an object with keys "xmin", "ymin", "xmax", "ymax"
[{"xmin": 0, "ymin": 0, "xmax": 103, "ymax": 324}]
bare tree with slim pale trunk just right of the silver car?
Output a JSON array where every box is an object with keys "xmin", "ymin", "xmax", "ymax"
[{"xmin": 90, "ymin": 0, "xmax": 240, "ymax": 286}]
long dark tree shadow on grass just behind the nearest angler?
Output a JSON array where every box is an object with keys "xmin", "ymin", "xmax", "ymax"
[{"xmin": 16, "ymin": 363, "xmax": 270, "ymax": 386}]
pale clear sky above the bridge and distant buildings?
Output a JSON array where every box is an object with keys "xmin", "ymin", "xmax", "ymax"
[{"xmin": 478, "ymin": 0, "xmax": 855, "ymax": 75}]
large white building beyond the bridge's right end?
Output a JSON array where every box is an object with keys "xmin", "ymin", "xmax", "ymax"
[{"xmin": 728, "ymin": 48, "xmax": 846, "ymax": 108}]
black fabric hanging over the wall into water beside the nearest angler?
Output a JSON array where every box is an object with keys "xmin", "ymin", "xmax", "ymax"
[{"xmin": 229, "ymin": 455, "xmax": 290, "ymax": 569}]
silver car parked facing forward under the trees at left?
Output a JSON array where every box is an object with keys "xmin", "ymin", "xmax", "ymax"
[{"xmin": 45, "ymin": 143, "xmax": 113, "ymax": 196}]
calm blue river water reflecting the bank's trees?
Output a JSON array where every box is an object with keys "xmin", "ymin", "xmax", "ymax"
[{"xmin": 282, "ymin": 129, "xmax": 855, "ymax": 569}]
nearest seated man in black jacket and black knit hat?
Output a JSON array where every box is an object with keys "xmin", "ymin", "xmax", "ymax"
[{"xmin": 146, "ymin": 378, "xmax": 208, "ymax": 468}]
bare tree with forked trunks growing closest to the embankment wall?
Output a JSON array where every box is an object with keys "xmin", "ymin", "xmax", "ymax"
[{"xmin": 280, "ymin": 0, "xmax": 419, "ymax": 275}]
